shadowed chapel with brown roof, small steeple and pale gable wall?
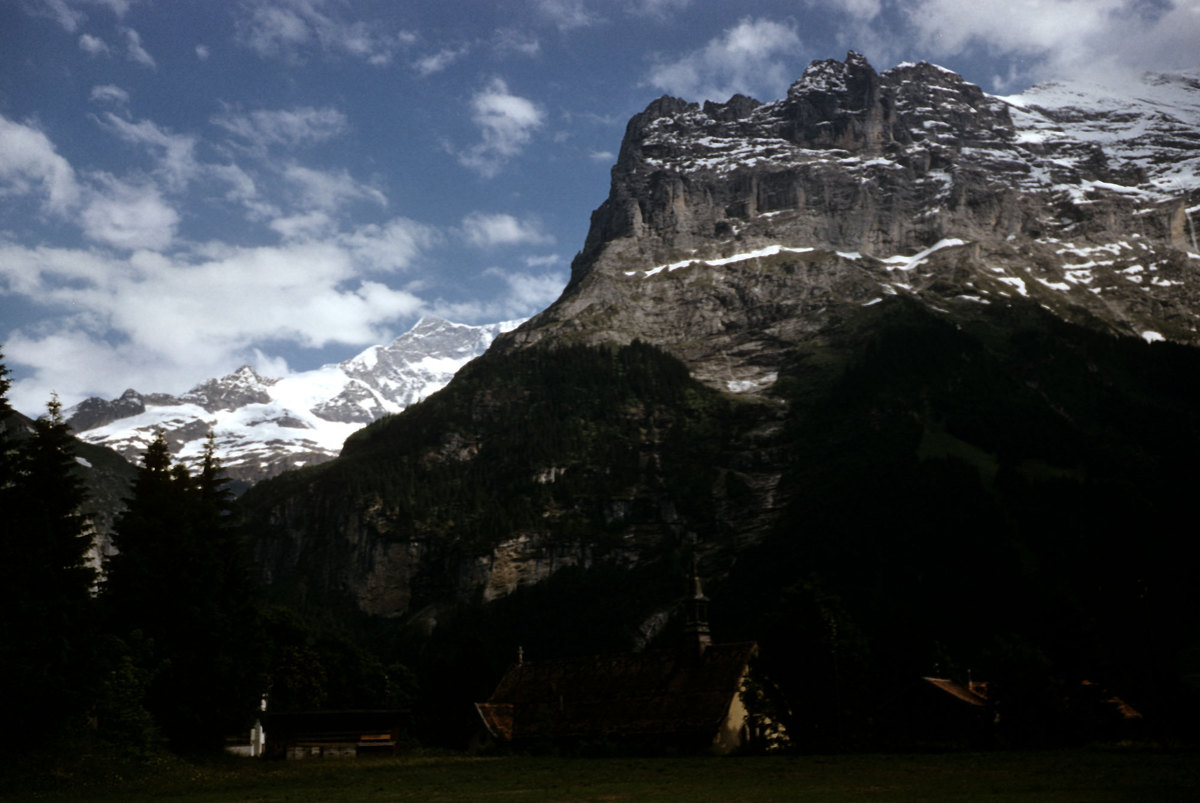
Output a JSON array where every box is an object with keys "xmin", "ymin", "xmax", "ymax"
[{"xmin": 476, "ymin": 556, "xmax": 758, "ymax": 754}]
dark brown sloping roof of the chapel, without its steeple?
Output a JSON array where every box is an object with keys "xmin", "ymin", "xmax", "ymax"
[{"xmin": 476, "ymin": 643, "xmax": 757, "ymax": 742}]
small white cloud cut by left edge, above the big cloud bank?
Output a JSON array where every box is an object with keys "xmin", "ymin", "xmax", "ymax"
[{"xmin": 0, "ymin": 115, "xmax": 80, "ymax": 214}]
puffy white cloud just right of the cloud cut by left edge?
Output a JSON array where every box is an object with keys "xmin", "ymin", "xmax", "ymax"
[{"xmin": 82, "ymin": 174, "xmax": 179, "ymax": 250}]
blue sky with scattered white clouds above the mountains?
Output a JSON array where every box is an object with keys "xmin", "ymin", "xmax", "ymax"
[{"xmin": 0, "ymin": 0, "xmax": 1200, "ymax": 414}]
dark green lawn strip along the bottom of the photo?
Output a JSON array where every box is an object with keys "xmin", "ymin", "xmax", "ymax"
[{"xmin": 0, "ymin": 750, "xmax": 1200, "ymax": 803}]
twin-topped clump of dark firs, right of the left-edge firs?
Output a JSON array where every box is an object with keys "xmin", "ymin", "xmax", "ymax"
[{"xmin": 104, "ymin": 435, "xmax": 260, "ymax": 750}]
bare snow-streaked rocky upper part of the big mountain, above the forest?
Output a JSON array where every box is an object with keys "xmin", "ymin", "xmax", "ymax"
[{"xmin": 502, "ymin": 53, "xmax": 1200, "ymax": 391}]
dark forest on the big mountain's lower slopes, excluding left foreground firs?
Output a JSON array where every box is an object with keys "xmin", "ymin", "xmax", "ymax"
[{"xmin": 238, "ymin": 299, "xmax": 1200, "ymax": 748}]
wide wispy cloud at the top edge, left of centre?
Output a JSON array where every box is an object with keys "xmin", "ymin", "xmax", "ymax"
[{"xmin": 238, "ymin": 0, "xmax": 416, "ymax": 66}]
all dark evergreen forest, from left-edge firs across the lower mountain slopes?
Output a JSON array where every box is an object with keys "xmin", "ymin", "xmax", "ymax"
[{"xmin": 0, "ymin": 299, "xmax": 1200, "ymax": 750}]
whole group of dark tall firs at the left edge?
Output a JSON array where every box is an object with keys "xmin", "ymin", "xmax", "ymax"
[{"xmin": 0, "ymin": 348, "xmax": 264, "ymax": 751}]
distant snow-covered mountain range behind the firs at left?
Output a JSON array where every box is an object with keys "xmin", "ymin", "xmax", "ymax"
[{"xmin": 66, "ymin": 317, "xmax": 520, "ymax": 484}]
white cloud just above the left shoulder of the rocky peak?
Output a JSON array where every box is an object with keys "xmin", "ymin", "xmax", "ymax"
[{"xmin": 647, "ymin": 18, "xmax": 800, "ymax": 101}]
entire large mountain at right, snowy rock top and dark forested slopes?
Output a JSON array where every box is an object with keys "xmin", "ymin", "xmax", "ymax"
[{"xmin": 241, "ymin": 53, "xmax": 1200, "ymax": 743}]
